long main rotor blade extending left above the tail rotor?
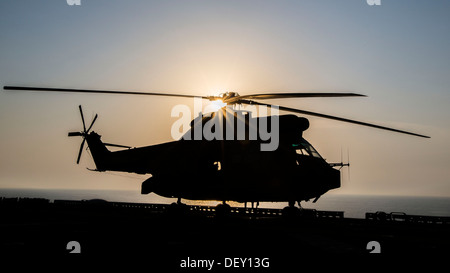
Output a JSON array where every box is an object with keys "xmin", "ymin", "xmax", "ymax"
[{"xmin": 3, "ymin": 86, "xmax": 212, "ymax": 99}]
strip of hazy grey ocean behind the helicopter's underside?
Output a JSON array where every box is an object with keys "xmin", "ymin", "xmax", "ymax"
[{"xmin": 0, "ymin": 189, "xmax": 450, "ymax": 218}]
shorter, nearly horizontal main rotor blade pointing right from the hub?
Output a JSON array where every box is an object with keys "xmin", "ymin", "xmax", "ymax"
[{"xmin": 226, "ymin": 93, "xmax": 367, "ymax": 102}]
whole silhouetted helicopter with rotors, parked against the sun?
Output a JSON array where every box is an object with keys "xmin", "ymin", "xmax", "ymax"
[{"xmin": 3, "ymin": 86, "xmax": 429, "ymax": 209}]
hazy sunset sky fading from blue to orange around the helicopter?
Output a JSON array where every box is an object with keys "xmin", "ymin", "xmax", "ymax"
[{"xmin": 0, "ymin": 0, "xmax": 450, "ymax": 197}]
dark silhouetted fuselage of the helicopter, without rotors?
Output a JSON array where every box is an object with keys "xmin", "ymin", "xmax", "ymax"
[{"xmin": 82, "ymin": 110, "xmax": 340, "ymax": 202}]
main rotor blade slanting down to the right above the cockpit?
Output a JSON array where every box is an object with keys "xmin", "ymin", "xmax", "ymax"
[{"xmin": 242, "ymin": 100, "xmax": 430, "ymax": 138}]
